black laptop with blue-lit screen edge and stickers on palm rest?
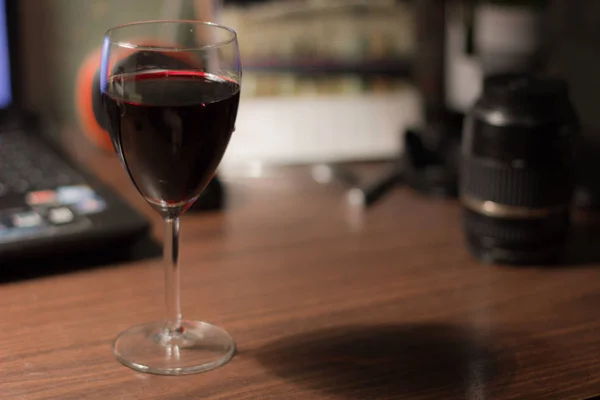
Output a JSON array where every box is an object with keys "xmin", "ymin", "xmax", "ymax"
[{"xmin": 0, "ymin": 0, "xmax": 149, "ymax": 261}]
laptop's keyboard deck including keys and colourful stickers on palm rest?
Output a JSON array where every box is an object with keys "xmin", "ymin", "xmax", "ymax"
[{"xmin": 0, "ymin": 126, "xmax": 106, "ymax": 244}]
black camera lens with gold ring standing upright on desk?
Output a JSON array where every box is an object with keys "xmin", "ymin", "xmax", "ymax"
[{"xmin": 460, "ymin": 74, "xmax": 578, "ymax": 264}]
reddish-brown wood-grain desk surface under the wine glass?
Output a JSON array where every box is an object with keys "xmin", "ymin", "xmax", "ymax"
[{"xmin": 0, "ymin": 142, "xmax": 600, "ymax": 400}]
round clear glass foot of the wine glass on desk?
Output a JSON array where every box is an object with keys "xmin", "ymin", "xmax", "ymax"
[{"xmin": 112, "ymin": 321, "xmax": 235, "ymax": 375}]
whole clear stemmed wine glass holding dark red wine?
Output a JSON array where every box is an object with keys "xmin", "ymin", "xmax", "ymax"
[{"xmin": 100, "ymin": 21, "xmax": 242, "ymax": 375}]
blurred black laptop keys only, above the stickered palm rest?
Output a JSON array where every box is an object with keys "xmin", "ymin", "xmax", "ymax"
[{"xmin": 0, "ymin": 129, "xmax": 85, "ymax": 197}]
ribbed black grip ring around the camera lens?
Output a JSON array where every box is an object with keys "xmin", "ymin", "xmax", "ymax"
[{"xmin": 460, "ymin": 156, "xmax": 573, "ymax": 208}]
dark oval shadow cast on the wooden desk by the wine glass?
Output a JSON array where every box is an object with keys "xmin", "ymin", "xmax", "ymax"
[{"xmin": 256, "ymin": 324, "xmax": 516, "ymax": 400}]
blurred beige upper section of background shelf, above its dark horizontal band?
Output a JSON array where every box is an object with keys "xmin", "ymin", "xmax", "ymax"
[{"xmin": 220, "ymin": 0, "xmax": 414, "ymax": 84}]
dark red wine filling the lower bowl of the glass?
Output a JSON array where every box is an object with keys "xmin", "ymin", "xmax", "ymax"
[{"xmin": 103, "ymin": 70, "xmax": 240, "ymax": 214}]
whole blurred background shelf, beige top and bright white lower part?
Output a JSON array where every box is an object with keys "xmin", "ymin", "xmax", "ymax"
[{"xmin": 219, "ymin": 0, "xmax": 420, "ymax": 164}]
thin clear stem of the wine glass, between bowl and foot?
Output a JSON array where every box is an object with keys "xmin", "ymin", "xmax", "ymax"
[{"xmin": 163, "ymin": 218, "xmax": 181, "ymax": 333}]
